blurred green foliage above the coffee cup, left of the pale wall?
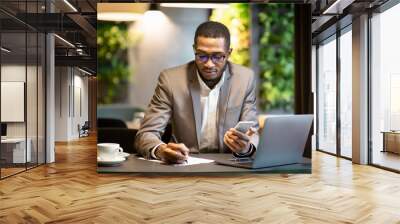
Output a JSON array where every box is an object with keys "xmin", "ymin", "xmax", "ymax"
[{"xmin": 97, "ymin": 21, "xmax": 137, "ymax": 104}]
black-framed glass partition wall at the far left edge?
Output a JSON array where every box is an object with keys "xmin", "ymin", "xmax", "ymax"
[{"xmin": 0, "ymin": 1, "xmax": 46, "ymax": 179}]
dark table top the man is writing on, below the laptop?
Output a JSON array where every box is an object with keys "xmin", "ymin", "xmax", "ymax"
[{"xmin": 97, "ymin": 153, "xmax": 311, "ymax": 175}]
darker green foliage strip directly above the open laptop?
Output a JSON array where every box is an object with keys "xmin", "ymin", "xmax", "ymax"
[{"xmin": 258, "ymin": 4, "xmax": 294, "ymax": 112}]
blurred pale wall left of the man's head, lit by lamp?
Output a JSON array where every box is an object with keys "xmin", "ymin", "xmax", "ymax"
[{"xmin": 129, "ymin": 8, "xmax": 208, "ymax": 108}]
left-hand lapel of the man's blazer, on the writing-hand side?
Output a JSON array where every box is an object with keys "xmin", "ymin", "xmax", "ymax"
[{"xmin": 188, "ymin": 63, "xmax": 201, "ymax": 149}]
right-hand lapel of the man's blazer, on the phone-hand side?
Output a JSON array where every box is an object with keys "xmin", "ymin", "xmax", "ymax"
[{"xmin": 217, "ymin": 62, "xmax": 232, "ymax": 152}]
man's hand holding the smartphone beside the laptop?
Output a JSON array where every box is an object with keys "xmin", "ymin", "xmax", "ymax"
[{"xmin": 224, "ymin": 128, "xmax": 254, "ymax": 154}]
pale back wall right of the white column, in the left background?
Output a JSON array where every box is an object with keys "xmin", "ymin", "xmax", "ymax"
[{"xmin": 55, "ymin": 67, "xmax": 88, "ymax": 141}]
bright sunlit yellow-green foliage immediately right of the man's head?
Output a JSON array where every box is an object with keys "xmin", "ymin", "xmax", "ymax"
[{"xmin": 210, "ymin": 3, "xmax": 250, "ymax": 66}]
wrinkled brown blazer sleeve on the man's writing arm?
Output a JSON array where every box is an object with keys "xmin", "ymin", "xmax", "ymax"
[{"xmin": 135, "ymin": 72, "xmax": 173, "ymax": 159}]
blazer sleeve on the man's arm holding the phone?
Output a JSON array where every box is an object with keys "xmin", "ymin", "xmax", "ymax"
[{"xmin": 240, "ymin": 72, "xmax": 259, "ymax": 149}]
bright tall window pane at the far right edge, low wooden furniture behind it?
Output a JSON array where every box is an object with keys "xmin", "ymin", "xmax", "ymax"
[{"xmin": 370, "ymin": 1, "xmax": 400, "ymax": 171}]
